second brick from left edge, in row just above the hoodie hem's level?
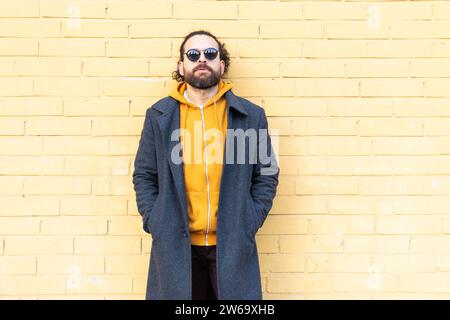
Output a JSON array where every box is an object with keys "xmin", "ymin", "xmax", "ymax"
[{"xmin": 41, "ymin": 217, "xmax": 108, "ymax": 235}]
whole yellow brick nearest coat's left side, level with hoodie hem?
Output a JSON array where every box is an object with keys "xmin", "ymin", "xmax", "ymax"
[{"xmin": 75, "ymin": 236, "xmax": 141, "ymax": 255}]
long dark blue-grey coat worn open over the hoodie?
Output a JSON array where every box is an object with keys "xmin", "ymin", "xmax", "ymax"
[{"xmin": 133, "ymin": 90, "xmax": 279, "ymax": 300}]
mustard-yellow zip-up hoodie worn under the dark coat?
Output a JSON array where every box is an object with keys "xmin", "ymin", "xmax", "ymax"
[{"xmin": 170, "ymin": 79, "xmax": 232, "ymax": 246}]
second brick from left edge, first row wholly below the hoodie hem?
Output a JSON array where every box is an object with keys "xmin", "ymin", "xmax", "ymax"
[{"xmin": 37, "ymin": 255, "xmax": 105, "ymax": 277}]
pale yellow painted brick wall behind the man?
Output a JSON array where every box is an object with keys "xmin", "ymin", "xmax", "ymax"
[{"xmin": 0, "ymin": 0, "xmax": 450, "ymax": 299}]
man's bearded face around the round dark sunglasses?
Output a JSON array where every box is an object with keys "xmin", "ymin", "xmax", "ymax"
[{"xmin": 178, "ymin": 35, "xmax": 225, "ymax": 89}]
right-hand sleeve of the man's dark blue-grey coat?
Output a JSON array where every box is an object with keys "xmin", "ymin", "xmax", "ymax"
[{"xmin": 250, "ymin": 109, "xmax": 280, "ymax": 228}]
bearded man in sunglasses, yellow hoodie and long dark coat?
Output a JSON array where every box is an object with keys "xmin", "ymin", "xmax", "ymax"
[{"xmin": 133, "ymin": 30, "xmax": 279, "ymax": 300}]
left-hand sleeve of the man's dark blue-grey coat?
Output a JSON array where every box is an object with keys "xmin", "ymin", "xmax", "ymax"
[{"xmin": 133, "ymin": 108, "xmax": 159, "ymax": 233}]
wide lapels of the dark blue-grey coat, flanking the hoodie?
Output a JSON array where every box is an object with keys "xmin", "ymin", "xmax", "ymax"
[{"xmin": 154, "ymin": 90, "xmax": 248, "ymax": 225}]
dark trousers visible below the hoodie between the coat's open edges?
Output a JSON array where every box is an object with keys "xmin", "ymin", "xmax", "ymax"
[{"xmin": 191, "ymin": 245, "xmax": 217, "ymax": 300}]
